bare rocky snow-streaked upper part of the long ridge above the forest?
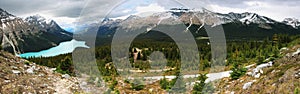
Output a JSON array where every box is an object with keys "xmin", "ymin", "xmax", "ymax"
[{"xmin": 98, "ymin": 8, "xmax": 300, "ymax": 29}]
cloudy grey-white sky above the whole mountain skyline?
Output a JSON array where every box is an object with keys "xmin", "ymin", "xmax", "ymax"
[{"xmin": 0, "ymin": 0, "xmax": 300, "ymax": 31}]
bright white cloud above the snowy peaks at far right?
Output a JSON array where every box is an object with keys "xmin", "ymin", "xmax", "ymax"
[{"xmin": 210, "ymin": 1, "xmax": 300, "ymax": 21}]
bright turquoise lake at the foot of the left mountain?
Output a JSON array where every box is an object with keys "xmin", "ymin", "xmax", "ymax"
[{"xmin": 19, "ymin": 39, "xmax": 89, "ymax": 58}]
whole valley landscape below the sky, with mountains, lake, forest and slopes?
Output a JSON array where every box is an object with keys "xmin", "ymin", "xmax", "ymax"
[{"xmin": 0, "ymin": 3, "xmax": 300, "ymax": 94}]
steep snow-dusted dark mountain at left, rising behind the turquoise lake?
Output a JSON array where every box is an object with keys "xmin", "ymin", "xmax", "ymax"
[{"xmin": 0, "ymin": 9, "xmax": 72, "ymax": 54}]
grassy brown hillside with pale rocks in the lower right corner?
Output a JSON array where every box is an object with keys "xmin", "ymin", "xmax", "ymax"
[{"xmin": 216, "ymin": 45, "xmax": 300, "ymax": 94}]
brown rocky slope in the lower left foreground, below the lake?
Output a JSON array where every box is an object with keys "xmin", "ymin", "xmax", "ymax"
[{"xmin": 0, "ymin": 51, "xmax": 82, "ymax": 94}]
